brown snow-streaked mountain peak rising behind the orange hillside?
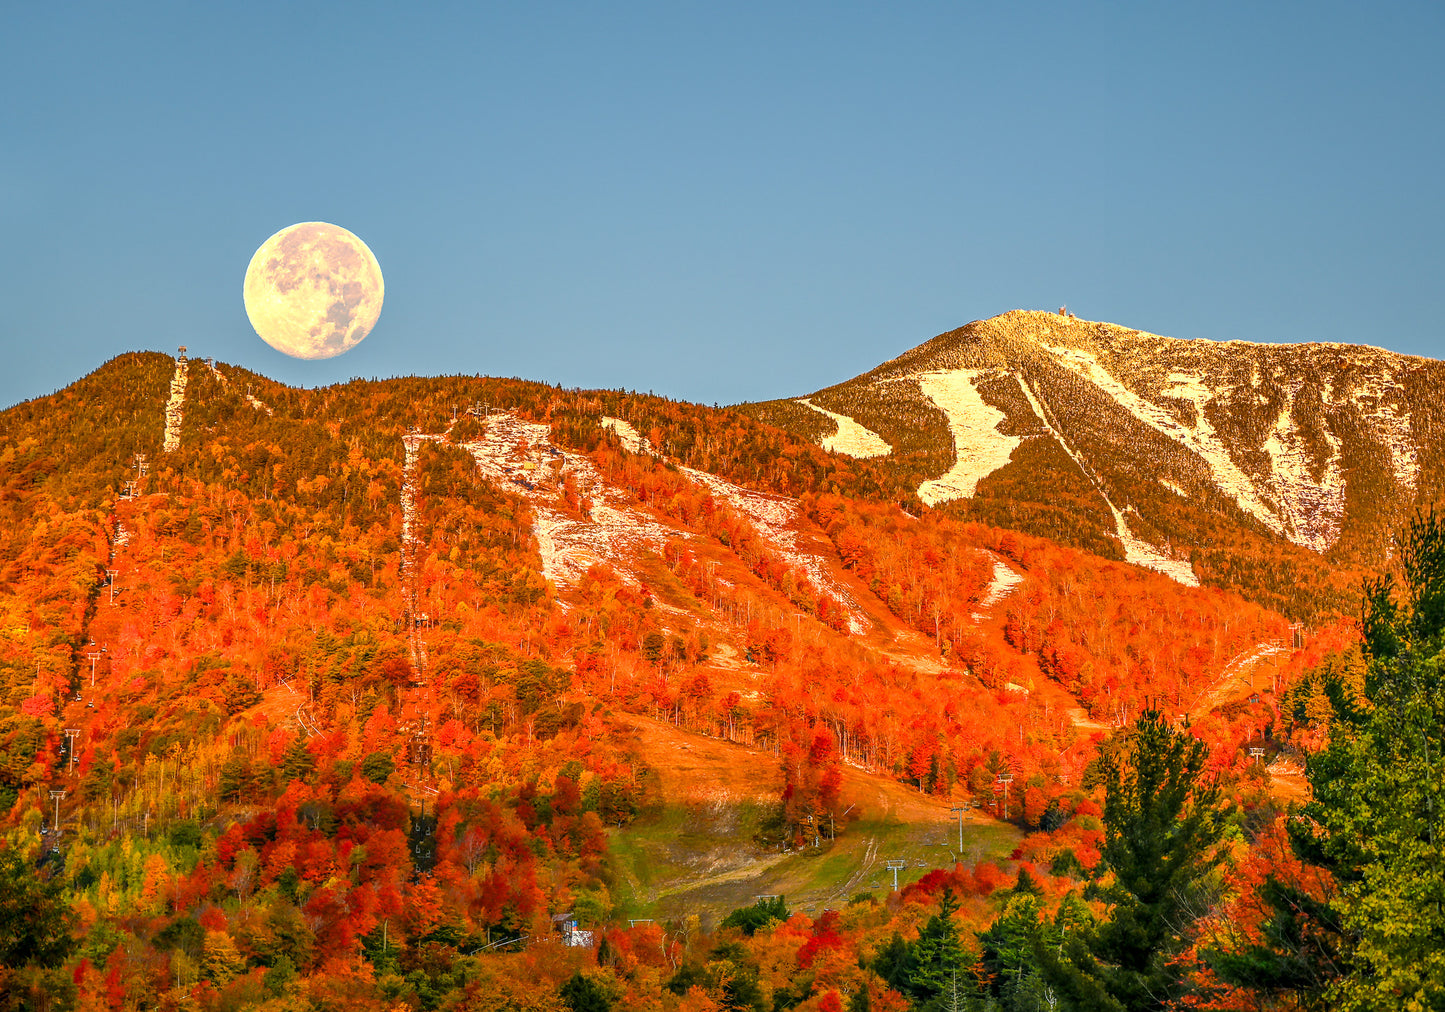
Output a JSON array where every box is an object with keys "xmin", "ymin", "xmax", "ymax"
[{"xmin": 741, "ymin": 311, "xmax": 1445, "ymax": 617}]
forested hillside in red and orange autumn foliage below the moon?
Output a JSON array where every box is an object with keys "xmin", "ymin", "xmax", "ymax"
[{"xmin": 0, "ymin": 354, "xmax": 1427, "ymax": 1012}]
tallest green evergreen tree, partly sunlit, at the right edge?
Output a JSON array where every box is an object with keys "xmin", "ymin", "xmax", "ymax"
[{"xmin": 1277, "ymin": 510, "xmax": 1445, "ymax": 1009}]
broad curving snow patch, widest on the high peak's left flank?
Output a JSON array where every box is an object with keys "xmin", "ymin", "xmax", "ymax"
[{"xmin": 916, "ymin": 369, "xmax": 1023, "ymax": 506}]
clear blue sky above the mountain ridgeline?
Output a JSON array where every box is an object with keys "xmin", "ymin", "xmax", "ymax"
[{"xmin": 0, "ymin": 0, "xmax": 1445, "ymax": 405}]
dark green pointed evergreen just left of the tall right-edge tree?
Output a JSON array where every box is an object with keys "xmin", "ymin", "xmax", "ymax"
[{"xmin": 1038, "ymin": 710, "xmax": 1225, "ymax": 1012}]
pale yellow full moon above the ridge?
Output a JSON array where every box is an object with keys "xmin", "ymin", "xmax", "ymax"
[{"xmin": 243, "ymin": 221, "xmax": 384, "ymax": 359}]
